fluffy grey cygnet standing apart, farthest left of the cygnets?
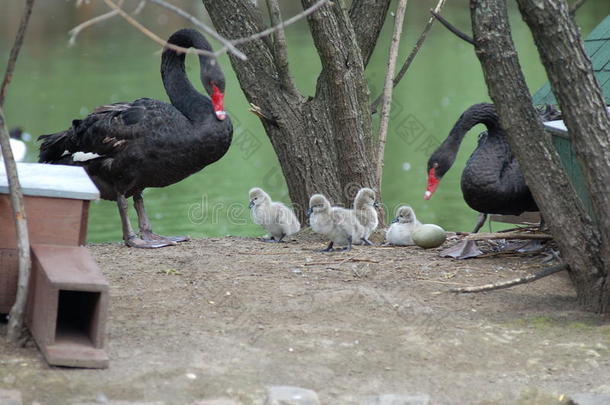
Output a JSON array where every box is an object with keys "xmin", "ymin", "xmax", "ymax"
[{"xmin": 250, "ymin": 187, "xmax": 301, "ymax": 242}]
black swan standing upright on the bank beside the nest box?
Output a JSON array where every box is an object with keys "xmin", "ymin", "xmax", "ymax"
[{"xmin": 39, "ymin": 29, "xmax": 233, "ymax": 248}]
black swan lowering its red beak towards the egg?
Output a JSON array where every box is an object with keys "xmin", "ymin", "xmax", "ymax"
[{"xmin": 424, "ymin": 103, "xmax": 538, "ymax": 219}]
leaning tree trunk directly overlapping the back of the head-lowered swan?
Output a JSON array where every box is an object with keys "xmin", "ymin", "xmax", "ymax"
[{"xmin": 470, "ymin": 0, "xmax": 610, "ymax": 312}]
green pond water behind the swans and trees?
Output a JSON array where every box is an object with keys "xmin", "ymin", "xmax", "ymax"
[{"xmin": 0, "ymin": 0, "xmax": 610, "ymax": 242}]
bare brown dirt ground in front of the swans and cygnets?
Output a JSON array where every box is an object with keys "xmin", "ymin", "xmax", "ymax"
[{"xmin": 0, "ymin": 230, "xmax": 610, "ymax": 405}]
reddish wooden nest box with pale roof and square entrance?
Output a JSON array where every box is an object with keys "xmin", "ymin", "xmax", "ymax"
[{"xmin": 0, "ymin": 163, "xmax": 108, "ymax": 368}]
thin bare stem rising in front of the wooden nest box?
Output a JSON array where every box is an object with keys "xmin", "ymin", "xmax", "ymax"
[{"xmin": 0, "ymin": 0, "xmax": 34, "ymax": 344}]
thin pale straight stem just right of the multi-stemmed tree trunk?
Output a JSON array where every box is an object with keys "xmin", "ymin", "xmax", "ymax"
[{"xmin": 375, "ymin": 0, "xmax": 407, "ymax": 218}]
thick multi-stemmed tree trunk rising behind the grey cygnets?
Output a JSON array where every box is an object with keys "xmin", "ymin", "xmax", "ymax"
[{"xmin": 202, "ymin": 0, "xmax": 390, "ymax": 220}]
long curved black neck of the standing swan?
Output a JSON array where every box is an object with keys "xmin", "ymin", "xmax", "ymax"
[{"xmin": 161, "ymin": 29, "xmax": 213, "ymax": 121}]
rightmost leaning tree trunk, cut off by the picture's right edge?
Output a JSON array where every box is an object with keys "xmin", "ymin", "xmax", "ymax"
[{"xmin": 518, "ymin": 0, "xmax": 610, "ymax": 310}]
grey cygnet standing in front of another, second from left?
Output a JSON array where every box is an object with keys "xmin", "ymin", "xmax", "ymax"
[{"xmin": 307, "ymin": 194, "xmax": 364, "ymax": 252}]
